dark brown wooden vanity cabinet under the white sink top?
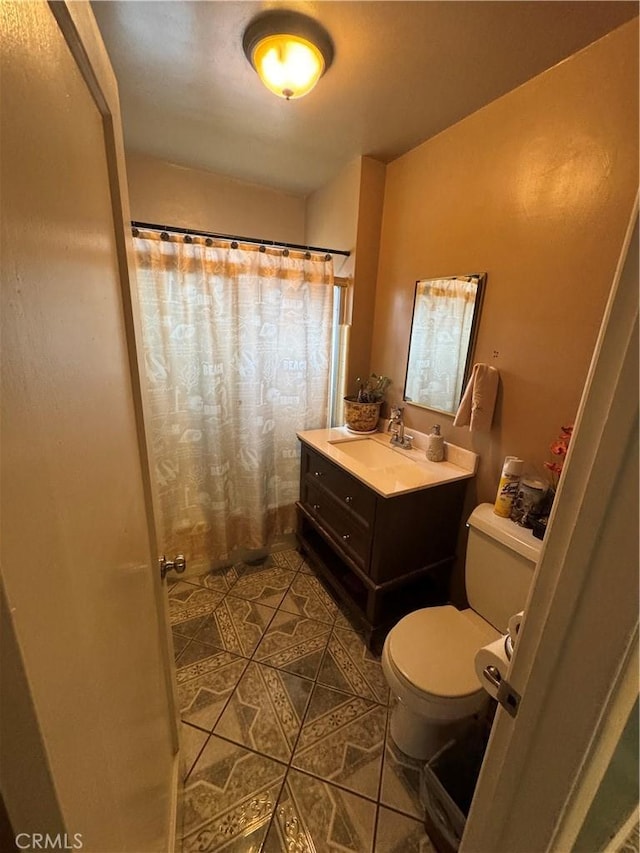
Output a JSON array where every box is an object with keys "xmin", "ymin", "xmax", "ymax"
[{"xmin": 297, "ymin": 441, "xmax": 467, "ymax": 648}]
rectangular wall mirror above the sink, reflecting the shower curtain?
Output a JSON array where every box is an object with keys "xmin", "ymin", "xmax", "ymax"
[{"xmin": 404, "ymin": 273, "xmax": 487, "ymax": 415}]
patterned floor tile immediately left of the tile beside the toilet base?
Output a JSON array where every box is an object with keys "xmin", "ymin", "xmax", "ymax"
[{"xmin": 215, "ymin": 662, "xmax": 313, "ymax": 762}]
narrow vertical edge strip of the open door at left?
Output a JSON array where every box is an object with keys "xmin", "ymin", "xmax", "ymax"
[{"xmin": 48, "ymin": 0, "xmax": 179, "ymax": 752}]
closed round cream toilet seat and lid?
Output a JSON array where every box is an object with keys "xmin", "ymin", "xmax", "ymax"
[{"xmin": 383, "ymin": 605, "xmax": 500, "ymax": 720}]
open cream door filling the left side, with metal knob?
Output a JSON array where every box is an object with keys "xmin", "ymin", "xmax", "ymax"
[{"xmin": 0, "ymin": 0, "xmax": 177, "ymax": 853}]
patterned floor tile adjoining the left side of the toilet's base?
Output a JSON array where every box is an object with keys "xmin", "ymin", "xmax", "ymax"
[{"xmin": 292, "ymin": 684, "xmax": 387, "ymax": 799}]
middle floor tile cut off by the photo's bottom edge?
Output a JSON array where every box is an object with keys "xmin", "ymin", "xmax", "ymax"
[{"xmin": 263, "ymin": 770, "xmax": 376, "ymax": 853}]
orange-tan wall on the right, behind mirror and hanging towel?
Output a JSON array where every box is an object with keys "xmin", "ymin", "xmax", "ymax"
[{"xmin": 371, "ymin": 20, "xmax": 638, "ymax": 505}]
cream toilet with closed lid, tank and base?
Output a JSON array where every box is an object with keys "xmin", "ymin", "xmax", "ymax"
[{"xmin": 382, "ymin": 504, "xmax": 542, "ymax": 760}]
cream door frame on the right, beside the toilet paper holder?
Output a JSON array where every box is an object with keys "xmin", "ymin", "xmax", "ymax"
[{"xmin": 460, "ymin": 196, "xmax": 638, "ymax": 853}]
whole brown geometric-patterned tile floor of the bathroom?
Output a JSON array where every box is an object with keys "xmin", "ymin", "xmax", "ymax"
[{"xmin": 169, "ymin": 550, "xmax": 433, "ymax": 853}]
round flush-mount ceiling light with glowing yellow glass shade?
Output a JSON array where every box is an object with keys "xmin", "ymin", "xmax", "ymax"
[{"xmin": 242, "ymin": 10, "xmax": 333, "ymax": 101}]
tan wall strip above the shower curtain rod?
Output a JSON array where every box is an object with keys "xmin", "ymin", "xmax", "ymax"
[{"xmin": 127, "ymin": 151, "xmax": 305, "ymax": 243}]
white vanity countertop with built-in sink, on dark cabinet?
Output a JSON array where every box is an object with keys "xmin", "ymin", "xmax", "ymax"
[{"xmin": 297, "ymin": 427, "xmax": 478, "ymax": 498}]
